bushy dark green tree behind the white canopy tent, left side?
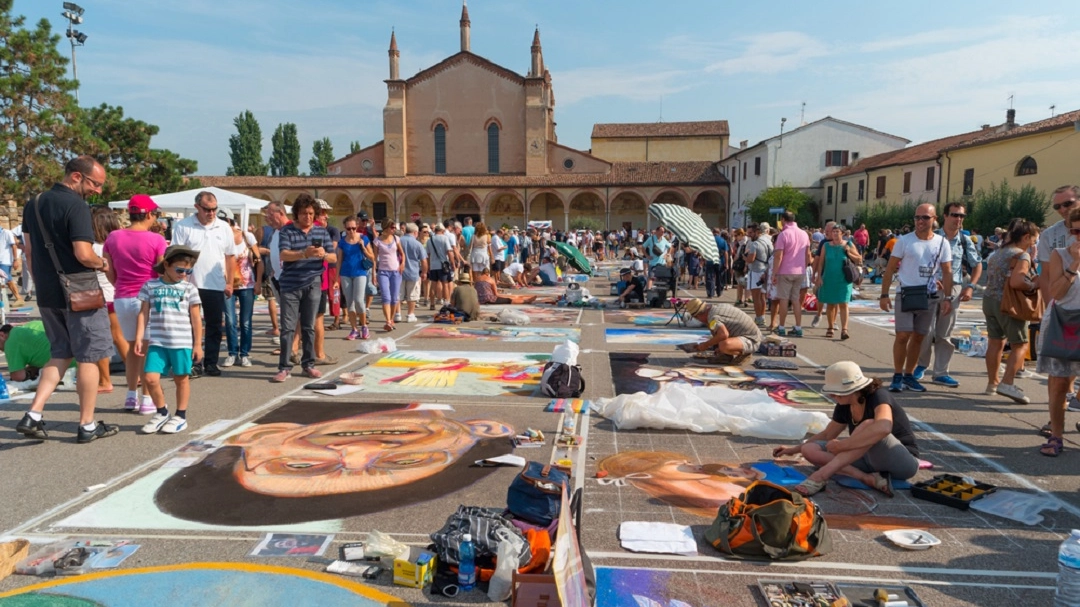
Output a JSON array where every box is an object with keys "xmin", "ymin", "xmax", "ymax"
[{"xmin": 82, "ymin": 104, "xmax": 200, "ymax": 201}]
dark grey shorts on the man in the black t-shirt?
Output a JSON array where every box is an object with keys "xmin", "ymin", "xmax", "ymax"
[{"xmin": 40, "ymin": 308, "xmax": 113, "ymax": 363}]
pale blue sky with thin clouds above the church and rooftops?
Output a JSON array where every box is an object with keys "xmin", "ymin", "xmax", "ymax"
[{"xmin": 13, "ymin": 0, "xmax": 1080, "ymax": 175}]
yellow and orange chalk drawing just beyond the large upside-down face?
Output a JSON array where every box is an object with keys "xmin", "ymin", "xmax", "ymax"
[{"xmin": 363, "ymin": 350, "xmax": 551, "ymax": 396}]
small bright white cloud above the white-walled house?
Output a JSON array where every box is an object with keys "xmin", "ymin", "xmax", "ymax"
[{"xmin": 705, "ymin": 31, "xmax": 829, "ymax": 76}]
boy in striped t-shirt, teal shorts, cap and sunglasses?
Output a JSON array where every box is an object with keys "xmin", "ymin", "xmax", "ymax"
[{"xmin": 135, "ymin": 244, "xmax": 203, "ymax": 434}]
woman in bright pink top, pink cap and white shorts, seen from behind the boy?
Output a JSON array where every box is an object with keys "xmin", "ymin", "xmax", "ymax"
[{"xmin": 104, "ymin": 194, "xmax": 165, "ymax": 415}]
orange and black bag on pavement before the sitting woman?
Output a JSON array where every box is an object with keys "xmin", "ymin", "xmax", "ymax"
[{"xmin": 705, "ymin": 481, "xmax": 832, "ymax": 561}]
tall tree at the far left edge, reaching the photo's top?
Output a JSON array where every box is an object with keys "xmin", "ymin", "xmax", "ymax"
[{"xmin": 0, "ymin": 0, "xmax": 89, "ymax": 200}]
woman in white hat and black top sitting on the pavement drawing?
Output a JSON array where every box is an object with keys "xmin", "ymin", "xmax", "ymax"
[{"xmin": 772, "ymin": 361, "xmax": 919, "ymax": 497}]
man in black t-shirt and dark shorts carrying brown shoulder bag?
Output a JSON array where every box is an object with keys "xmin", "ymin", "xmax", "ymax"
[{"xmin": 15, "ymin": 156, "xmax": 120, "ymax": 443}]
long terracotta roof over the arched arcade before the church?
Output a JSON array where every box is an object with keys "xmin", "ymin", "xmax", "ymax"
[{"xmin": 197, "ymin": 161, "xmax": 728, "ymax": 189}]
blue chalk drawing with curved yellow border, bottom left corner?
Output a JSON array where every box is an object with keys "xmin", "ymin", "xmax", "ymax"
[{"xmin": 0, "ymin": 563, "xmax": 408, "ymax": 607}]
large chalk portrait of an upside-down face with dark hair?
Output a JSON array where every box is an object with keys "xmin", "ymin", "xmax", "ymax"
[{"xmin": 58, "ymin": 401, "xmax": 514, "ymax": 532}]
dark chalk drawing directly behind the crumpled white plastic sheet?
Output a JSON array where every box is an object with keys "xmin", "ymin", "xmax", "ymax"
[{"xmin": 609, "ymin": 352, "xmax": 833, "ymax": 410}]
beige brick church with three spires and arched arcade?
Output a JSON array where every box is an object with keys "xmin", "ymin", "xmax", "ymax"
[{"xmin": 200, "ymin": 6, "xmax": 730, "ymax": 228}]
